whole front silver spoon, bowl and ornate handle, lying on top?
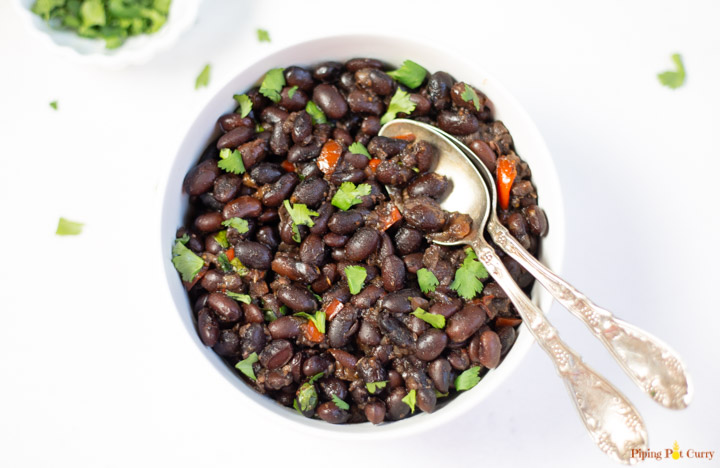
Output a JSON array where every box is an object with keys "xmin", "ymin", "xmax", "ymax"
[{"xmin": 379, "ymin": 120, "xmax": 647, "ymax": 464}]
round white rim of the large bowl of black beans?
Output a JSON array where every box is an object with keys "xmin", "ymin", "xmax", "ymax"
[{"xmin": 158, "ymin": 34, "xmax": 565, "ymax": 440}]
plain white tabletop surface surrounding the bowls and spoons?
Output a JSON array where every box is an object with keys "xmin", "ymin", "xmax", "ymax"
[{"xmin": 0, "ymin": 0, "xmax": 720, "ymax": 468}]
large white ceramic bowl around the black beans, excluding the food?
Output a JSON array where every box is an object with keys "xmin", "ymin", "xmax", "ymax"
[{"xmin": 160, "ymin": 35, "xmax": 565, "ymax": 440}]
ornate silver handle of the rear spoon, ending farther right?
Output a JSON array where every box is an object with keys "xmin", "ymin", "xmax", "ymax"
[{"xmin": 487, "ymin": 217, "xmax": 691, "ymax": 409}]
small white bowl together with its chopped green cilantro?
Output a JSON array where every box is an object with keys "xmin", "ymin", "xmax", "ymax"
[{"xmin": 17, "ymin": 0, "xmax": 200, "ymax": 68}]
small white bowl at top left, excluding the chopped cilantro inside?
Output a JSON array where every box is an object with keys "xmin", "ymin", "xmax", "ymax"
[{"xmin": 15, "ymin": 0, "xmax": 201, "ymax": 70}]
